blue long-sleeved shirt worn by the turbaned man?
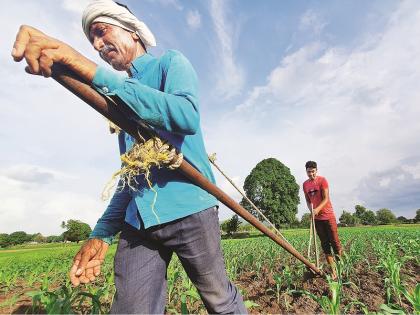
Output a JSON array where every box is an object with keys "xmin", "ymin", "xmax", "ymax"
[{"xmin": 90, "ymin": 50, "xmax": 218, "ymax": 242}]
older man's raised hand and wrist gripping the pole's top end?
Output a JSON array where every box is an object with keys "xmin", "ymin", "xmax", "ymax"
[{"xmin": 12, "ymin": 25, "xmax": 96, "ymax": 83}]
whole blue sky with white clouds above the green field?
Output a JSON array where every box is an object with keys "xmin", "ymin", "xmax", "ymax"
[{"xmin": 0, "ymin": 0, "xmax": 420, "ymax": 235}]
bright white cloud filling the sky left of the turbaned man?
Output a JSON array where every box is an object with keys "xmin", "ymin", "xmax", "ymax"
[{"xmin": 0, "ymin": 1, "xmax": 119, "ymax": 235}]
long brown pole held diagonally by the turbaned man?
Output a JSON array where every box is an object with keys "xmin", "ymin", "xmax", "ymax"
[{"xmin": 52, "ymin": 64, "xmax": 323, "ymax": 275}]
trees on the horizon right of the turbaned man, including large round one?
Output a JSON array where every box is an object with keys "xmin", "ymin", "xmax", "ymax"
[{"xmin": 220, "ymin": 158, "xmax": 420, "ymax": 234}]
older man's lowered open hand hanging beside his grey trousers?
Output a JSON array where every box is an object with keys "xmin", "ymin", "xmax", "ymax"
[{"xmin": 70, "ymin": 239, "xmax": 109, "ymax": 287}]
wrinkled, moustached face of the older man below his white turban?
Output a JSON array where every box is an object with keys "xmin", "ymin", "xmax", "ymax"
[{"xmin": 89, "ymin": 22, "xmax": 138, "ymax": 71}]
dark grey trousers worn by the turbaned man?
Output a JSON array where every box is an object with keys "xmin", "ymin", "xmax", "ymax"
[{"xmin": 111, "ymin": 207, "xmax": 247, "ymax": 314}]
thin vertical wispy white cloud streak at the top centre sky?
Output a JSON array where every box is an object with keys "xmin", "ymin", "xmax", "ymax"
[{"xmin": 210, "ymin": 0, "xmax": 245, "ymax": 99}]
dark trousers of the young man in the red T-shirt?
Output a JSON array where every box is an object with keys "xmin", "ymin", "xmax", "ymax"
[{"xmin": 315, "ymin": 217, "xmax": 341, "ymax": 255}]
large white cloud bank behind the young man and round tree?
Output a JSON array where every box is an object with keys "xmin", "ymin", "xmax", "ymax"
[{"xmin": 208, "ymin": 1, "xmax": 420, "ymax": 221}]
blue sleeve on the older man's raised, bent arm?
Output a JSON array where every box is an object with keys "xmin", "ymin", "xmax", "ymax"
[{"xmin": 93, "ymin": 52, "xmax": 200, "ymax": 135}]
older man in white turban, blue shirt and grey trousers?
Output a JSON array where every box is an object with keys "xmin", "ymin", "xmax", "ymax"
[{"xmin": 12, "ymin": 0, "xmax": 247, "ymax": 314}]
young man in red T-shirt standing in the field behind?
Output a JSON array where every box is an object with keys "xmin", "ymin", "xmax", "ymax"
[{"xmin": 303, "ymin": 161, "xmax": 341, "ymax": 278}]
